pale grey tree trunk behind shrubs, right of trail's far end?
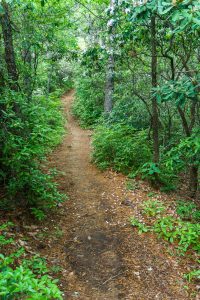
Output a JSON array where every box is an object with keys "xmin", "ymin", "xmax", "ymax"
[{"xmin": 104, "ymin": 54, "xmax": 115, "ymax": 114}]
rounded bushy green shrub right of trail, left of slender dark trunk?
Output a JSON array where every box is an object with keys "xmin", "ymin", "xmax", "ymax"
[{"xmin": 93, "ymin": 124, "xmax": 151, "ymax": 174}]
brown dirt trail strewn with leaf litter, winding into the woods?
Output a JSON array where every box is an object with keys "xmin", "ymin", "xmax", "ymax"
[{"xmin": 48, "ymin": 92, "xmax": 189, "ymax": 300}]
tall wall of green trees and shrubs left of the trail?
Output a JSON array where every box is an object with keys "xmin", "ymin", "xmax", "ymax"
[{"xmin": 0, "ymin": 1, "xmax": 76, "ymax": 219}]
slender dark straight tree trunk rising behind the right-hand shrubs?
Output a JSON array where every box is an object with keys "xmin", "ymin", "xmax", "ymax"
[{"xmin": 151, "ymin": 16, "xmax": 160, "ymax": 163}]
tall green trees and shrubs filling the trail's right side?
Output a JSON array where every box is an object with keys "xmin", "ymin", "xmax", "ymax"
[{"xmin": 74, "ymin": 0, "xmax": 200, "ymax": 197}]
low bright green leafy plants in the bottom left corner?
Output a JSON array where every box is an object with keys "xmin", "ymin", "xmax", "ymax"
[{"xmin": 0, "ymin": 222, "xmax": 62, "ymax": 300}]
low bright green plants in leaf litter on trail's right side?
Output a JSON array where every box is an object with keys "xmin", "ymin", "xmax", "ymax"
[{"xmin": 130, "ymin": 199, "xmax": 200, "ymax": 281}]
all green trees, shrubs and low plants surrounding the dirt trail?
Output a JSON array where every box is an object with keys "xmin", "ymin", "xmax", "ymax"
[{"xmin": 0, "ymin": 0, "xmax": 200, "ymax": 299}]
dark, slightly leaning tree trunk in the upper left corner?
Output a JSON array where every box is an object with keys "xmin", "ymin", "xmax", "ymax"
[{"xmin": 0, "ymin": 1, "xmax": 19, "ymax": 91}]
